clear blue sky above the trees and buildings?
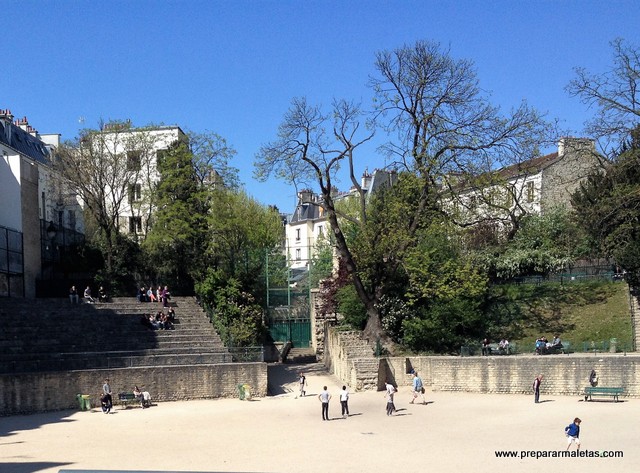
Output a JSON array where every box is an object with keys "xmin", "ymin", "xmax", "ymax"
[{"xmin": 5, "ymin": 0, "xmax": 640, "ymax": 212}]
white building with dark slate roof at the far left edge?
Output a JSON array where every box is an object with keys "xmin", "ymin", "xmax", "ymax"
[{"xmin": 0, "ymin": 110, "xmax": 78, "ymax": 297}]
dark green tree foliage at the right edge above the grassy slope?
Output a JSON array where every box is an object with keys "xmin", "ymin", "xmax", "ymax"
[{"xmin": 572, "ymin": 133, "xmax": 640, "ymax": 285}]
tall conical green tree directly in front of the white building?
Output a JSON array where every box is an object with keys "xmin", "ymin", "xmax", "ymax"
[{"xmin": 142, "ymin": 138, "xmax": 209, "ymax": 293}]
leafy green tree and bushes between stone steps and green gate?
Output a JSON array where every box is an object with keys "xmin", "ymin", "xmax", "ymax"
[{"xmin": 196, "ymin": 188, "xmax": 282, "ymax": 346}]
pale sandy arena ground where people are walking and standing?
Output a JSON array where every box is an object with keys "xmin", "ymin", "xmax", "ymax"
[{"xmin": 0, "ymin": 365, "xmax": 640, "ymax": 473}]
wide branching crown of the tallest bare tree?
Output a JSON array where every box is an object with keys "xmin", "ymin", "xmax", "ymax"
[{"xmin": 370, "ymin": 41, "xmax": 556, "ymax": 241}]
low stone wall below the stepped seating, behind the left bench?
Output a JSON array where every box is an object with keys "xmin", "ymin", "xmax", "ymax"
[{"xmin": 0, "ymin": 363, "xmax": 267, "ymax": 415}]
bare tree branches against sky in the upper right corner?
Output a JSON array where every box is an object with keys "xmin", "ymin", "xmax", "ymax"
[{"xmin": 566, "ymin": 38, "xmax": 640, "ymax": 158}]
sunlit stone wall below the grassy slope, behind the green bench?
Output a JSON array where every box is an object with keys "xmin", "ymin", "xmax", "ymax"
[{"xmin": 324, "ymin": 322, "xmax": 640, "ymax": 397}]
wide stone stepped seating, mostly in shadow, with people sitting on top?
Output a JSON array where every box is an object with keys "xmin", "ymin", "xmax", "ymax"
[{"xmin": 0, "ymin": 297, "xmax": 232, "ymax": 373}]
